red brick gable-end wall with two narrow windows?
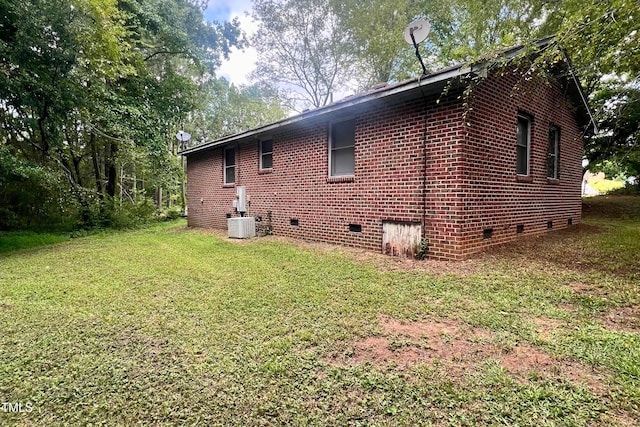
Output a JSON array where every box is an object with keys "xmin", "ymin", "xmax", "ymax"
[{"xmin": 460, "ymin": 71, "xmax": 582, "ymax": 260}]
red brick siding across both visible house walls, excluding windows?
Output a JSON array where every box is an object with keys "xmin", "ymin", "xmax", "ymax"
[{"xmin": 187, "ymin": 68, "xmax": 582, "ymax": 259}]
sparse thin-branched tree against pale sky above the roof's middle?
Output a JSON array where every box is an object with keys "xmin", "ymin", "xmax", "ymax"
[{"xmin": 252, "ymin": 0, "xmax": 355, "ymax": 110}]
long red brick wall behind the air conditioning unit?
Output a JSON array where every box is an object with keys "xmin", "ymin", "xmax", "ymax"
[{"xmin": 188, "ymin": 95, "xmax": 447, "ymax": 251}]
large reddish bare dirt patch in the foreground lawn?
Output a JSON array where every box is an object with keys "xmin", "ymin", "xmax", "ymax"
[{"xmin": 330, "ymin": 315, "xmax": 606, "ymax": 395}]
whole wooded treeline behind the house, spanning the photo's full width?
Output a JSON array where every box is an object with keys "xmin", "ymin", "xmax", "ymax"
[{"xmin": 0, "ymin": 0, "xmax": 640, "ymax": 229}]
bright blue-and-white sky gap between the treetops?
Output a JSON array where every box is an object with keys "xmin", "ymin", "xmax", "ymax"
[{"xmin": 204, "ymin": 0, "xmax": 257, "ymax": 85}]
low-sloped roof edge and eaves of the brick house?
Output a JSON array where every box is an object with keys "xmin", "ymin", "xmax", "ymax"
[{"xmin": 180, "ymin": 37, "xmax": 595, "ymax": 155}]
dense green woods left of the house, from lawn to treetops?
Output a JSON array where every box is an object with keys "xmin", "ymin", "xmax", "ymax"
[{"xmin": 0, "ymin": 0, "xmax": 284, "ymax": 229}]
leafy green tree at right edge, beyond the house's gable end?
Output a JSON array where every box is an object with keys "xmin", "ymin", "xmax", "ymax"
[{"xmin": 541, "ymin": 0, "xmax": 640, "ymax": 176}]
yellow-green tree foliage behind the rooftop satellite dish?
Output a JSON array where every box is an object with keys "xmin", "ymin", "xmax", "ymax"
[{"xmin": 332, "ymin": 0, "xmax": 542, "ymax": 88}]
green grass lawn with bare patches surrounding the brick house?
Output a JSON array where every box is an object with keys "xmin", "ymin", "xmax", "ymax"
[{"xmin": 0, "ymin": 197, "xmax": 640, "ymax": 426}]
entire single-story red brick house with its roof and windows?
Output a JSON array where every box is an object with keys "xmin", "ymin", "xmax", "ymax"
[{"xmin": 183, "ymin": 41, "xmax": 592, "ymax": 260}]
